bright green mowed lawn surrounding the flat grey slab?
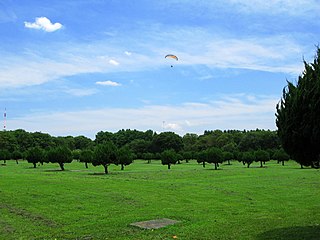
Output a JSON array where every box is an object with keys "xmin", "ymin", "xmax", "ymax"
[{"xmin": 0, "ymin": 160, "xmax": 320, "ymax": 240}]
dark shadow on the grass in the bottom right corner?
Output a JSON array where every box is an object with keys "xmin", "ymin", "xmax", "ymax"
[{"xmin": 256, "ymin": 226, "xmax": 320, "ymax": 240}]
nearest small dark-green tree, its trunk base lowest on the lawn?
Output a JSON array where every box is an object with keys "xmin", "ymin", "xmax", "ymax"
[{"xmin": 92, "ymin": 142, "xmax": 117, "ymax": 174}]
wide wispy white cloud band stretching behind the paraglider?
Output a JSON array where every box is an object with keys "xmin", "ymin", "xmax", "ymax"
[{"xmin": 0, "ymin": 21, "xmax": 313, "ymax": 87}]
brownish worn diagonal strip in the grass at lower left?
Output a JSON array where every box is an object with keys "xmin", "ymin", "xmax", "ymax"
[{"xmin": 0, "ymin": 204, "xmax": 58, "ymax": 227}]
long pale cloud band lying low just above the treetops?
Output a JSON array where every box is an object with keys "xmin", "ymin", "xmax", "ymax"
[{"xmin": 8, "ymin": 94, "xmax": 279, "ymax": 138}]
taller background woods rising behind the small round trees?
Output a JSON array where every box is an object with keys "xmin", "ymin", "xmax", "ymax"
[{"xmin": 0, "ymin": 129, "xmax": 281, "ymax": 154}]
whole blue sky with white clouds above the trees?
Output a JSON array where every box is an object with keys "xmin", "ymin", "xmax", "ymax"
[{"xmin": 0, "ymin": 0, "xmax": 320, "ymax": 139}]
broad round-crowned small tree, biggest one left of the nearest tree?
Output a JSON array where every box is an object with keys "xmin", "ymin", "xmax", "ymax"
[{"xmin": 48, "ymin": 146, "xmax": 73, "ymax": 171}]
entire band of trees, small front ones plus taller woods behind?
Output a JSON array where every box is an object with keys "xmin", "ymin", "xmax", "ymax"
[{"xmin": 0, "ymin": 129, "xmax": 290, "ymax": 173}]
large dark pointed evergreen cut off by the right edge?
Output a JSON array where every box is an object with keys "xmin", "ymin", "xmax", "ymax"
[{"xmin": 276, "ymin": 47, "xmax": 320, "ymax": 168}]
